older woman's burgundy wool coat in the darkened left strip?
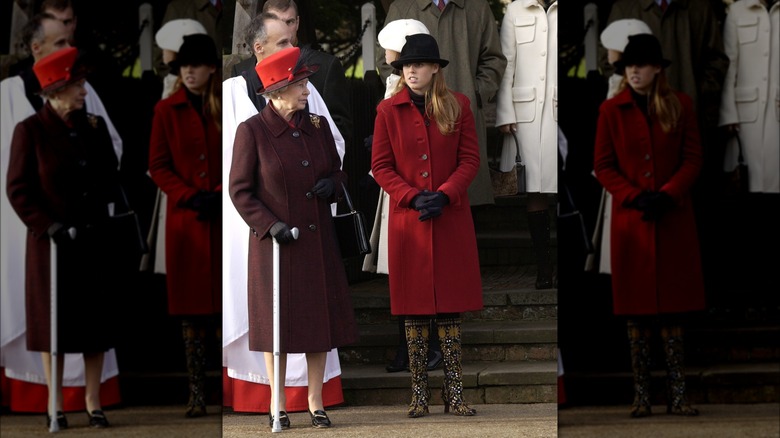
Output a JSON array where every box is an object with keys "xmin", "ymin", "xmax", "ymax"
[{"xmin": 6, "ymin": 104, "xmax": 127, "ymax": 353}]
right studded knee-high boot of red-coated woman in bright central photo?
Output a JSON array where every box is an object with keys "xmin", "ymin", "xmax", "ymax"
[{"xmin": 436, "ymin": 318, "xmax": 477, "ymax": 416}]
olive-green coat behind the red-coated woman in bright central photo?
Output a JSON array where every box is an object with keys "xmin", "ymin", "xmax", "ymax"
[{"xmin": 379, "ymin": 0, "xmax": 506, "ymax": 206}]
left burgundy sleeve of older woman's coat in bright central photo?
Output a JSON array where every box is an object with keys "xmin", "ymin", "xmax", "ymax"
[{"xmin": 228, "ymin": 122, "xmax": 279, "ymax": 239}]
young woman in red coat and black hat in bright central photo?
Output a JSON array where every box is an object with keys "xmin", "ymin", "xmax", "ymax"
[{"xmin": 371, "ymin": 34, "xmax": 482, "ymax": 417}]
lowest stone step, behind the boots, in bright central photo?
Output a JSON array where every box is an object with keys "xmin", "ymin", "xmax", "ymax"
[{"xmin": 341, "ymin": 360, "xmax": 557, "ymax": 409}]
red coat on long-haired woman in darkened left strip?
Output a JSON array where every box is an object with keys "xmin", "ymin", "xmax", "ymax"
[{"xmin": 149, "ymin": 87, "xmax": 222, "ymax": 315}]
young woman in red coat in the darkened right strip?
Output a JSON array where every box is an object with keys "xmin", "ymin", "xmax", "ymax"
[{"xmin": 594, "ymin": 34, "xmax": 705, "ymax": 417}]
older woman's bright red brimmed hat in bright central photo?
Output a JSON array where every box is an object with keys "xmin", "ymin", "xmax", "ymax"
[{"xmin": 255, "ymin": 47, "xmax": 320, "ymax": 94}]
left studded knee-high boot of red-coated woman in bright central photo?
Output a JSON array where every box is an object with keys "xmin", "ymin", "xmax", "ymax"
[{"xmin": 404, "ymin": 318, "xmax": 431, "ymax": 418}]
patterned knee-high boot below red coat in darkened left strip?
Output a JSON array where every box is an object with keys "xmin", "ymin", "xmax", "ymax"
[{"xmin": 182, "ymin": 320, "xmax": 206, "ymax": 418}]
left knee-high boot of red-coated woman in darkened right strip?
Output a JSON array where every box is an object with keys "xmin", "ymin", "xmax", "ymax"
[{"xmin": 628, "ymin": 320, "xmax": 652, "ymax": 417}]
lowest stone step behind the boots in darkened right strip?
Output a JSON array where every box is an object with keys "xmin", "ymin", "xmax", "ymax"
[{"xmin": 563, "ymin": 362, "xmax": 780, "ymax": 406}]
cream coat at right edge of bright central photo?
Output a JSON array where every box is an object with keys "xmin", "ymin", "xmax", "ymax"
[{"xmin": 496, "ymin": 0, "xmax": 558, "ymax": 193}]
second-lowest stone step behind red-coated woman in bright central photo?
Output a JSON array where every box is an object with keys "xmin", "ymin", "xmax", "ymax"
[{"xmin": 339, "ymin": 320, "xmax": 558, "ymax": 365}]
